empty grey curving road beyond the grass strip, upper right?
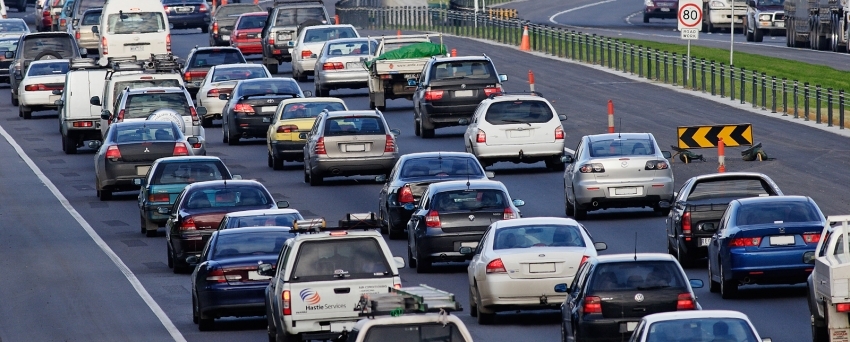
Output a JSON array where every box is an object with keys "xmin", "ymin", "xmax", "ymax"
[{"xmin": 499, "ymin": 0, "xmax": 850, "ymax": 70}]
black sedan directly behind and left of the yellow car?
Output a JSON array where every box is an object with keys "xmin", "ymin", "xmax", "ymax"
[{"xmin": 219, "ymin": 77, "xmax": 313, "ymax": 145}]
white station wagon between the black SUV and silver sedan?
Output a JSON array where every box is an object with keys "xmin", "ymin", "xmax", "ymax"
[{"xmin": 463, "ymin": 93, "xmax": 567, "ymax": 170}]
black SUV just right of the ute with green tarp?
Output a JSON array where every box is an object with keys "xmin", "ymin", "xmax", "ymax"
[{"xmin": 413, "ymin": 55, "xmax": 508, "ymax": 138}]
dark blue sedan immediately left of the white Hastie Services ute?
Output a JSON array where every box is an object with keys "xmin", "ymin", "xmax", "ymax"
[{"xmin": 190, "ymin": 227, "xmax": 292, "ymax": 331}]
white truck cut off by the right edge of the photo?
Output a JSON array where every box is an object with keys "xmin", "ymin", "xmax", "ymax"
[{"xmin": 803, "ymin": 215, "xmax": 850, "ymax": 342}]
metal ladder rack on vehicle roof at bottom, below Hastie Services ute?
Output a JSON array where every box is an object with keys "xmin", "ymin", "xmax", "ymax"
[{"xmin": 354, "ymin": 284, "xmax": 463, "ymax": 318}]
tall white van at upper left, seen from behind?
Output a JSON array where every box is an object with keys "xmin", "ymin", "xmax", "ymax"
[{"xmin": 92, "ymin": 0, "xmax": 171, "ymax": 65}]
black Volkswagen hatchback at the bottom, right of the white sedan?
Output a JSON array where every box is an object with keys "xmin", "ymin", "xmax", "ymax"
[{"xmin": 555, "ymin": 253, "xmax": 703, "ymax": 342}]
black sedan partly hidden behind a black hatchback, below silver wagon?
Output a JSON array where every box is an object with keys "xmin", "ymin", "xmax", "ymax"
[{"xmin": 378, "ymin": 152, "xmax": 493, "ymax": 239}]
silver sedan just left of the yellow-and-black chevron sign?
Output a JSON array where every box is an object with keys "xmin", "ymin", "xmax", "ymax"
[{"xmin": 564, "ymin": 133, "xmax": 673, "ymax": 219}]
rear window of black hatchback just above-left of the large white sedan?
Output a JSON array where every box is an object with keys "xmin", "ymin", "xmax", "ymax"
[{"xmin": 430, "ymin": 189, "xmax": 508, "ymax": 211}]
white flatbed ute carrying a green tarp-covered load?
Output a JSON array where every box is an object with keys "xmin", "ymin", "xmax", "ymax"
[{"xmin": 366, "ymin": 34, "xmax": 445, "ymax": 110}]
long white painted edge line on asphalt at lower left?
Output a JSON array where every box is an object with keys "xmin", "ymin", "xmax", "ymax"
[{"xmin": 0, "ymin": 126, "xmax": 186, "ymax": 342}]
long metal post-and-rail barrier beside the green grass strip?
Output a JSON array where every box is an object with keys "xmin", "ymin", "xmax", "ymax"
[{"xmin": 336, "ymin": 0, "xmax": 847, "ymax": 129}]
